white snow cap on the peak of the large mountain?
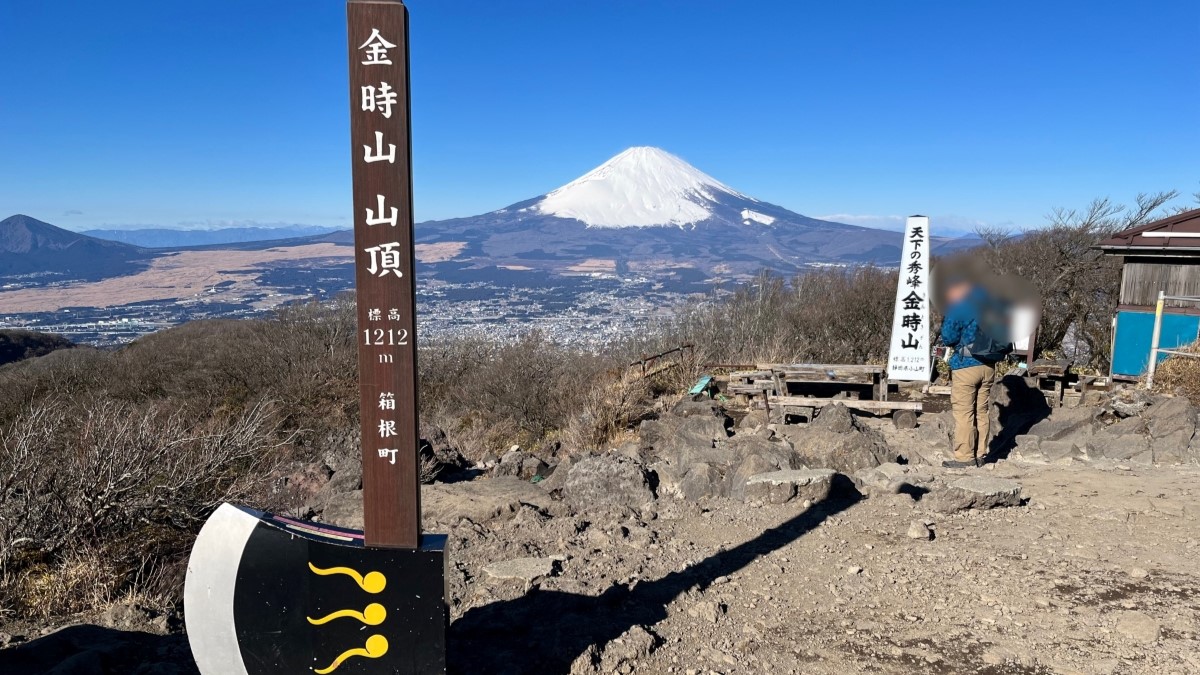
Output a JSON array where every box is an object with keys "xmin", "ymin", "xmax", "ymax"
[{"xmin": 533, "ymin": 147, "xmax": 746, "ymax": 227}]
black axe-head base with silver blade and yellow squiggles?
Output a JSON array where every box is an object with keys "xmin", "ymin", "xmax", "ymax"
[{"xmin": 184, "ymin": 504, "xmax": 449, "ymax": 675}]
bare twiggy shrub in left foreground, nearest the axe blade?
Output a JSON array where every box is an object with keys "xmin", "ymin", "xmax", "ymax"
[{"xmin": 0, "ymin": 400, "xmax": 287, "ymax": 611}]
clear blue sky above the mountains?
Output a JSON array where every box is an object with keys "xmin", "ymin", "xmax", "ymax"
[{"xmin": 0, "ymin": 0, "xmax": 1200, "ymax": 229}]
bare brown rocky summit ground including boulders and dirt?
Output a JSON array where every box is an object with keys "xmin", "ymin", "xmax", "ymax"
[{"xmin": 0, "ymin": 380, "xmax": 1200, "ymax": 675}]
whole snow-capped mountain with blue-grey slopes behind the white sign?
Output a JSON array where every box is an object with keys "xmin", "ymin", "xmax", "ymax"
[{"xmin": 405, "ymin": 147, "xmax": 974, "ymax": 282}]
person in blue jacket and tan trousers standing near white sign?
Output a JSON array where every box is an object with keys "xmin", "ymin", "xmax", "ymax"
[{"xmin": 942, "ymin": 280, "xmax": 996, "ymax": 468}]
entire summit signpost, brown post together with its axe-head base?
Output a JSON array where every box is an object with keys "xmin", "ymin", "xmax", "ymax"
[{"xmin": 184, "ymin": 0, "xmax": 450, "ymax": 675}]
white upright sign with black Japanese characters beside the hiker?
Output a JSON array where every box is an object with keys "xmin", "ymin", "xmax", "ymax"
[{"xmin": 888, "ymin": 216, "xmax": 931, "ymax": 382}]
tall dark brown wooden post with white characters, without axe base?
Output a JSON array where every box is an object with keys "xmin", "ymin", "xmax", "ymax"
[{"xmin": 346, "ymin": 0, "xmax": 421, "ymax": 548}]
